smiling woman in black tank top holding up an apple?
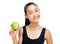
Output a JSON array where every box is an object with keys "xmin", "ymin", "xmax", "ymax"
[{"xmin": 9, "ymin": 2, "xmax": 53, "ymax": 44}]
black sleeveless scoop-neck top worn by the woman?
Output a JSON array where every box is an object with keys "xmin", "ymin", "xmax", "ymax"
[{"xmin": 22, "ymin": 26, "xmax": 46, "ymax": 44}]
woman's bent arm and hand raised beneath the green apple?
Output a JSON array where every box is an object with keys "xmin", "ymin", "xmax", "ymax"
[{"xmin": 9, "ymin": 28, "xmax": 23, "ymax": 44}]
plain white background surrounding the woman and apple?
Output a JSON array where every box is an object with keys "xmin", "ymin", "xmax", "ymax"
[{"xmin": 0, "ymin": 0, "xmax": 60, "ymax": 44}]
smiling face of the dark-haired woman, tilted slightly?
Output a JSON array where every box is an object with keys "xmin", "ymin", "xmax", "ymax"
[{"xmin": 26, "ymin": 4, "xmax": 40, "ymax": 22}]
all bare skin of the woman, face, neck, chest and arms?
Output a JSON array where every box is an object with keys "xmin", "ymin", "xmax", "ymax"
[{"xmin": 9, "ymin": 4, "xmax": 53, "ymax": 44}]
